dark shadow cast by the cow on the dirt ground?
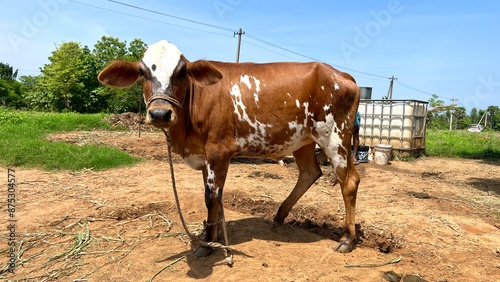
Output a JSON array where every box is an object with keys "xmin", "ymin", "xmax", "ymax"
[{"xmin": 161, "ymin": 217, "xmax": 348, "ymax": 279}]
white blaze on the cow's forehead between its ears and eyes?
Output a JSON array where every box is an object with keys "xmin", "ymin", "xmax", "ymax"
[{"xmin": 142, "ymin": 40, "xmax": 182, "ymax": 93}]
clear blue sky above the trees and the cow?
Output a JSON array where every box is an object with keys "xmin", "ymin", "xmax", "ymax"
[{"xmin": 0, "ymin": 0, "xmax": 500, "ymax": 111}]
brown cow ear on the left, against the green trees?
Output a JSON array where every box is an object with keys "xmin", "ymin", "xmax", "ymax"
[{"xmin": 97, "ymin": 61, "xmax": 140, "ymax": 88}]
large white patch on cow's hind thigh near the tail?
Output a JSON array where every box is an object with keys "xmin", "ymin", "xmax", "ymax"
[{"xmin": 312, "ymin": 113, "xmax": 347, "ymax": 169}]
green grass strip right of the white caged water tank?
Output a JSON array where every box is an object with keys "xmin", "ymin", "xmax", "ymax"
[{"xmin": 426, "ymin": 129, "xmax": 500, "ymax": 161}]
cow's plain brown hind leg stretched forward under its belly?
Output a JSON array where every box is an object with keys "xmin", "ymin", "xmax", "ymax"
[{"xmin": 274, "ymin": 143, "xmax": 322, "ymax": 226}]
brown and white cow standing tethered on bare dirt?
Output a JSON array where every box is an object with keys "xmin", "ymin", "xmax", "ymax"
[{"xmin": 99, "ymin": 41, "xmax": 359, "ymax": 255}]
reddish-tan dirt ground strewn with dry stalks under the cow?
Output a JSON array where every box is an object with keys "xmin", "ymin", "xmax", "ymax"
[{"xmin": 0, "ymin": 131, "xmax": 500, "ymax": 281}]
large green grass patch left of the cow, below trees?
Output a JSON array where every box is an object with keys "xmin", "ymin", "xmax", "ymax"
[{"xmin": 0, "ymin": 109, "xmax": 140, "ymax": 171}]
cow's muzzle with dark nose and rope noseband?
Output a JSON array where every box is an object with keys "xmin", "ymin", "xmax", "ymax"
[{"xmin": 146, "ymin": 94, "xmax": 182, "ymax": 128}]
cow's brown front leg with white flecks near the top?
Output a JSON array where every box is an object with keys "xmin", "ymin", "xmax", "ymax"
[{"xmin": 194, "ymin": 160, "xmax": 229, "ymax": 256}]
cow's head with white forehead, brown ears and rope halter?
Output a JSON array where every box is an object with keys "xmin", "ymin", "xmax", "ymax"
[{"xmin": 98, "ymin": 40, "xmax": 222, "ymax": 128}]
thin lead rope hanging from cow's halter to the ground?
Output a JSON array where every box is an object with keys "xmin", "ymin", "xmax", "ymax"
[{"xmin": 161, "ymin": 128, "xmax": 234, "ymax": 266}]
